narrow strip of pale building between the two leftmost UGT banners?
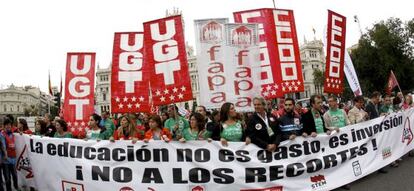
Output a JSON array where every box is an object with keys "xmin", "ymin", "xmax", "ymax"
[{"xmin": 95, "ymin": 64, "xmax": 112, "ymax": 114}]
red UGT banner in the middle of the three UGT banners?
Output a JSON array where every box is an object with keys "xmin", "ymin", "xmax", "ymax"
[{"xmin": 111, "ymin": 32, "xmax": 151, "ymax": 113}]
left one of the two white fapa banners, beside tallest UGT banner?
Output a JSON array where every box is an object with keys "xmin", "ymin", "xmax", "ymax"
[{"xmin": 194, "ymin": 18, "xmax": 232, "ymax": 109}]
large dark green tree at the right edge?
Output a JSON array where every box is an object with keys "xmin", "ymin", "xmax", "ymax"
[{"xmin": 351, "ymin": 18, "xmax": 414, "ymax": 94}]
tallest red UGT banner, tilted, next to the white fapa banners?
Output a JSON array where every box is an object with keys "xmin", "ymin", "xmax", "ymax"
[{"xmin": 144, "ymin": 16, "xmax": 193, "ymax": 106}]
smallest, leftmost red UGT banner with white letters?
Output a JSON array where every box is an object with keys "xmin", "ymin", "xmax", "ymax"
[{"xmin": 64, "ymin": 52, "xmax": 95, "ymax": 136}]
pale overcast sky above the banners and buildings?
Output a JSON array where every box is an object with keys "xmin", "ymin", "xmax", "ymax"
[{"xmin": 0, "ymin": 0, "xmax": 414, "ymax": 92}]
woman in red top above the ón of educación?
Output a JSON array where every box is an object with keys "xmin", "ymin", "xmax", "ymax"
[{"xmin": 144, "ymin": 115, "xmax": 172, "ymax": 143}]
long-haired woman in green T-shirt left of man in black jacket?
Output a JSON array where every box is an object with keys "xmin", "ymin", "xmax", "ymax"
[{"xmin": 220, "ymin": 102, "xmax": 245, "ymax": 146}]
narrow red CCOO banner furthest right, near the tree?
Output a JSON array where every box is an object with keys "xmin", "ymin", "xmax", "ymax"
[{"xmin": 323, "ymin": 10, "xmax": 346, "ymax": 94}]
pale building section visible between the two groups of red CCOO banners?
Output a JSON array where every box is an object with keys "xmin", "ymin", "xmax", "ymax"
[{"xmin": 300, "ymin": 39, "xmax": 326, "ymax": 98}]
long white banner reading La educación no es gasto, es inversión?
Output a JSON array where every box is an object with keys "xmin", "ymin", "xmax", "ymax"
[{"xmin": 16, "ymin": 109, "xmax": 414, "ymax": 191}]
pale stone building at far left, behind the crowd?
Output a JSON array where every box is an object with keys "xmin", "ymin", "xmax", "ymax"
[{"xmin": 0, "ymin": 84, "xmax": 54, "ymax": 117}]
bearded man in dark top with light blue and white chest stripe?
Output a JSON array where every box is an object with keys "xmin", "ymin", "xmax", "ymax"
[{"xmin": 278, "ymin": 98, "xmax": 303, "ymax": 141}]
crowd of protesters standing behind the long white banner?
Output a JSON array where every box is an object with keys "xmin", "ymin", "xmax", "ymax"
[{"xmin": 0, "ymin": 92, "xmax": 413, "ymax": 191}]
